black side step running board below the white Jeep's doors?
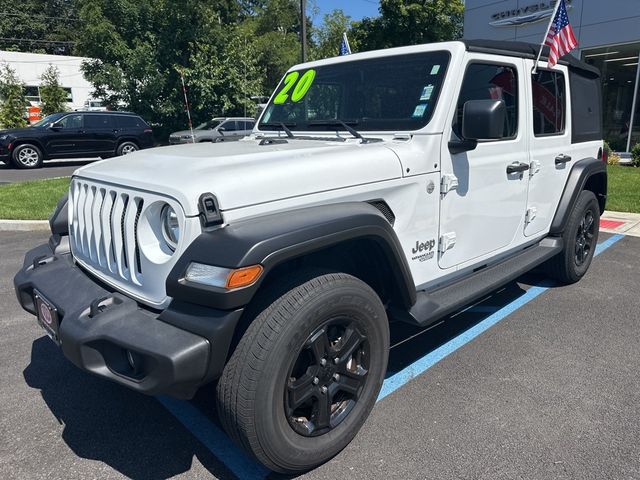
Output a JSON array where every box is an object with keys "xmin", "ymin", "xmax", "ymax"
[{"xmin": 389, "ymin": 237, "xmax": 563, "ymax": 327}]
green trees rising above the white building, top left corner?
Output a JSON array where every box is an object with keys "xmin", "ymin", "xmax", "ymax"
[{"xmin": 0, "ymin": 0, "xmax": 81, "ymax": 55}]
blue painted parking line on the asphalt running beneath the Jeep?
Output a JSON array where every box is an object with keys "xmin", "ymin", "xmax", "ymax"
[{"xmin": 158, "ymin": 235, "xmax": 624, "ymax": 480}]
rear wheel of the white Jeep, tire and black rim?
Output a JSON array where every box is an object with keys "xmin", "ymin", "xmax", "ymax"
[{"xmin": 546, "ymin": 190, "xmax": 600, "ymax": 284}]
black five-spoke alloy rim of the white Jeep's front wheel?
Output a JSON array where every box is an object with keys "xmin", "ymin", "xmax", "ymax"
[{"xmin": 284, "ymin": 318, "xmax": 370, "ymax": 437}]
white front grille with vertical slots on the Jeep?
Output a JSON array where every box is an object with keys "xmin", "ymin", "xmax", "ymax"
[{"xmin": 69, "ymin": 177, "xmax": 198, "ymax": 306}]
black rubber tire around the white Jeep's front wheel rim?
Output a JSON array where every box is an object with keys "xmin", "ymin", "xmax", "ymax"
[{"xmin": 217, "ymin": 273, "xmax": 389, "ymax": 474}]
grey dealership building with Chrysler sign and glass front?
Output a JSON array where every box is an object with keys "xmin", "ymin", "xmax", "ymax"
[{"xmin": 464, "ymin": 0, "xmax": 640, "ymax": 152}]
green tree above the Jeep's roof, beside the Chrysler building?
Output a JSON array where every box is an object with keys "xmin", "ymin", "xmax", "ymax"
[{"xmin": 352, "ymin": 0, "xmax": 464, "ymax": 51}]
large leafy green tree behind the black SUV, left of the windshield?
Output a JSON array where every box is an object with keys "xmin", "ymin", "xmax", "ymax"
[{"xmin": 78, "ymin": 0, "xmax": 261, "ymax": 136}]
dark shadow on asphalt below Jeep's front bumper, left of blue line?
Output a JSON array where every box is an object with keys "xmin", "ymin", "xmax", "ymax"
[{"xmin": 23, "ymin": 337, "xmax": 235, "ymax": 479}]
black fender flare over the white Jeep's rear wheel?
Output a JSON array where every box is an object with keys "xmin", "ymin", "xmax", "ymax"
[{"xmin": 549, "ymin": 157, "xmax": 607, "ymax": 235}]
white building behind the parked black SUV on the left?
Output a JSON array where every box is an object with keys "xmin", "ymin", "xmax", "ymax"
[{"xmin": 0, "ymin": 50, "xmax": 93, "ymax": 110}]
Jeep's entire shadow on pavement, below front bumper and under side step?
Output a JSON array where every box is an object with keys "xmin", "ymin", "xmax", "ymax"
[{"xmin": 23, "ymin": 274, "xmax": 544, "ymax": 479}]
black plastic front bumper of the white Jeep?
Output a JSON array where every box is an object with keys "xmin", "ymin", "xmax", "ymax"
[{"xmin": 14, "ymin": 236, "xmax": 242, "ymax": 398}]
